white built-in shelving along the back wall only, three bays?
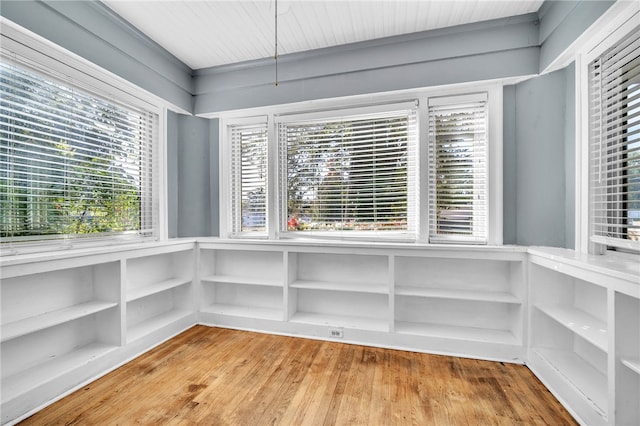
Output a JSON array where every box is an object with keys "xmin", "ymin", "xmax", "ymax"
[{"xmin": 198, "ymin": 240, "xmax": 527, "ymax": 362}]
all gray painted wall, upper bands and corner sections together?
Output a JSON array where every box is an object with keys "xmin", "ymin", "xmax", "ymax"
[{"xmin": 0, "ymin": 0, "xmax": 613, "ymax": 247}]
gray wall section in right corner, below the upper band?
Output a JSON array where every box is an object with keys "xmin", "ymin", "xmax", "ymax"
[{"xmin": 504, "ymin": 65, "xmax": 575, "ymax": 248}]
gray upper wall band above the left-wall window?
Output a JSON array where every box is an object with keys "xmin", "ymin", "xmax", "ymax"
[{"xmin": 0, "ymin": 0, "xmax": 193, "ymax": 112}]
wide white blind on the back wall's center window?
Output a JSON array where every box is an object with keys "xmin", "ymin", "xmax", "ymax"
[{"xmin": 278, "ymin": 102, "xmax": 418, "ymax": 237}]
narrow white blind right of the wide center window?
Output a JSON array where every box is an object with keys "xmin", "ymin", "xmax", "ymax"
[{"xmin": 429, "ymin": 94, "xmax": 489, "ymax": 244}]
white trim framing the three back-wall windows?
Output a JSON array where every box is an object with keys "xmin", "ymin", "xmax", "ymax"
[{"xmin": 216, "ymin": 81, "xmax": 504, "ymax": 246}]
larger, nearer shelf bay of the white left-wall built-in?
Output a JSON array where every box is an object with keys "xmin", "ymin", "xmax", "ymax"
[{"xmin": 0, "ymin": 262, "xmax": 121, "ymax": 424}]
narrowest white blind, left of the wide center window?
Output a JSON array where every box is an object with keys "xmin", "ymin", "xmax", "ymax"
[{"xmin": 229, "ymin": 123, "xmax": 268, "ymax": 234}]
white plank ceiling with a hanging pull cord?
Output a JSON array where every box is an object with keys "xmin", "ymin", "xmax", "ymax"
[{"xmin": 103, "ymin": 0, "xmax": 543, "ymax": 69}]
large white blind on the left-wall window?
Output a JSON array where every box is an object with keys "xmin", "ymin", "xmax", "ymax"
[{"xmin": 0, "ymin": 59, "xmax": 158, "ymax": 242}]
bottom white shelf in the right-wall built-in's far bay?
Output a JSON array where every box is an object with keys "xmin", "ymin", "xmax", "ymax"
[{"xmin": 534, "ymin": 348, "xmax": 608, "ymax": 417}]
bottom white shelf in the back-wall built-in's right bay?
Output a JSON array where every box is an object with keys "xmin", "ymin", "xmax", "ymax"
[{"xmin": 395, "ymin": 321, "xmax": 520, "ymax": 345}]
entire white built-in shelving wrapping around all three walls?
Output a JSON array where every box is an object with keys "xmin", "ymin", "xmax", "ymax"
[{"xmin": 0, "ymin": 238, "xmax": 640, "ymax": 425}]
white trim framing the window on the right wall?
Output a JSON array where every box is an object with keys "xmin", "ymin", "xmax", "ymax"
[{"xmin": 575, "ymin": 1, "xmax": 640, "ymax": 254}]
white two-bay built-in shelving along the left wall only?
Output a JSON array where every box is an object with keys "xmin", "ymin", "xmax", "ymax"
[{"xmin": 0, "ymin": 242, "xmax": 196, "ymax": 424}]
